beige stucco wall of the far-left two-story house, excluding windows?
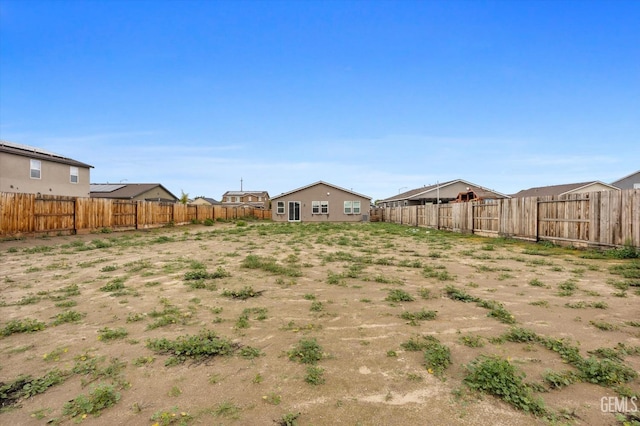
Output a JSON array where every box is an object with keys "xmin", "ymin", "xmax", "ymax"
[{"xmin": 0, "ymin": 152, "xmax": 90, "ymax": 197}]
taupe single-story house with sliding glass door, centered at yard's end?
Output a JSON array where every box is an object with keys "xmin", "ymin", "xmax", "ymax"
[{"xmin": 271, "ymin": 181, "xmax": 371, "ymax": 222}]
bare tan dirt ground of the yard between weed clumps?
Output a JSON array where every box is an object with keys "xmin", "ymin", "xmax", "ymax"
[{"xmin": 0, "ymin": 222, "xmax": 640, "ymax": 425}]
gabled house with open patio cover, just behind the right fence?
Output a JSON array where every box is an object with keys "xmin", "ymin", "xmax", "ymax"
[{"xmin": 377, "ymin": 179, "xmax": 510, "ymax": 207}]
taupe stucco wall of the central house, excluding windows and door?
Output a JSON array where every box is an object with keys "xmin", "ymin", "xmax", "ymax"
[{"xmin": 271, "ymin": 184, "xmax": 371, "ymax": 222}]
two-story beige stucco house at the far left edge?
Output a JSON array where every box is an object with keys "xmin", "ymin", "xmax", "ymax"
[{"xmin": 0, "ymin": 141, "xmax": 93, "ymax": 197}]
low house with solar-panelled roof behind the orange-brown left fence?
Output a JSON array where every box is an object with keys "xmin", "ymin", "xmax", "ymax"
[{"xmin": 91, "ymin": 183, "xmax": 179, "ymax": 203}]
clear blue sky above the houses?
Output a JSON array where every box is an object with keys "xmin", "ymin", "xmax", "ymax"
[{"xmin": 0, "ymin": 0, "xmax": 640, "ymax": 200}]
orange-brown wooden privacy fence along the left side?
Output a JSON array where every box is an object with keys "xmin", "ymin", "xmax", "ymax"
[{"xmin": 0, "ymin": 192, "xmax": 271, "ymax": 237}]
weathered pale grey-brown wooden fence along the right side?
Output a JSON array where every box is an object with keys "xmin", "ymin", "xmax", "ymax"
[{"xmin": 371, "ymin": 189, "xmax": 640, "ymax": 247}]
